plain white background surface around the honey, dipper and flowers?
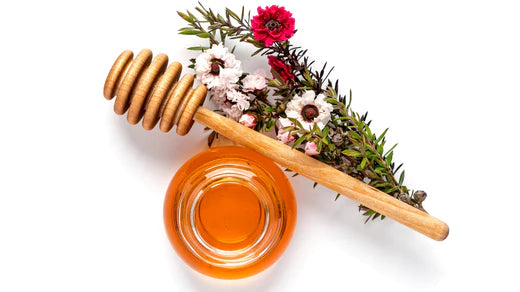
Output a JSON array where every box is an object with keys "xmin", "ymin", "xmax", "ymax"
[{"xmin": 0, "ymin": 0, "xmax": 520, "ymax": 291}]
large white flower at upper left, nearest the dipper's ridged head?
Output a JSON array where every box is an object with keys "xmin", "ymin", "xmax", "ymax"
[{"xmin": 195, "ymin": 44, "xmax": 242, "ymax": 89}]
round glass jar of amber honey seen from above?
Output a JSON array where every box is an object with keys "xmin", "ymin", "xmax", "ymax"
[{"xmin": 164, "ymin": 146, "xmax": 296, "ymax": 279}]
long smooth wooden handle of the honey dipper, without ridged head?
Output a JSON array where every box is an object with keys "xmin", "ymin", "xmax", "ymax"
[{"xmin": 194, "ymin": 107, "xmax": 449, "ymax": 241}]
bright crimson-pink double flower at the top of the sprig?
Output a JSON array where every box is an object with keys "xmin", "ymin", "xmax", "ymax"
[{"xmin": 251, "ymin": 5, "xmax": 294, "ymax": 47}]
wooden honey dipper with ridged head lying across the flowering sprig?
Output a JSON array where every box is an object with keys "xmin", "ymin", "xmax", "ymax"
[{"xmin": 104, "ymin": 49, "xmax": 449, "ymax": 241}]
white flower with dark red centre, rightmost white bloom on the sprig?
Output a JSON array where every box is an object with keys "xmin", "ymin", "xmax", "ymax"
[{"xmin": 285, "ymin": 90, "xmax": 333, "ymax": 130}]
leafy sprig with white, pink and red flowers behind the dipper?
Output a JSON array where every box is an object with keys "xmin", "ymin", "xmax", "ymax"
[{"xmin": 178, "ymin": 3, "xmax": 426, "ymax": 222}]
